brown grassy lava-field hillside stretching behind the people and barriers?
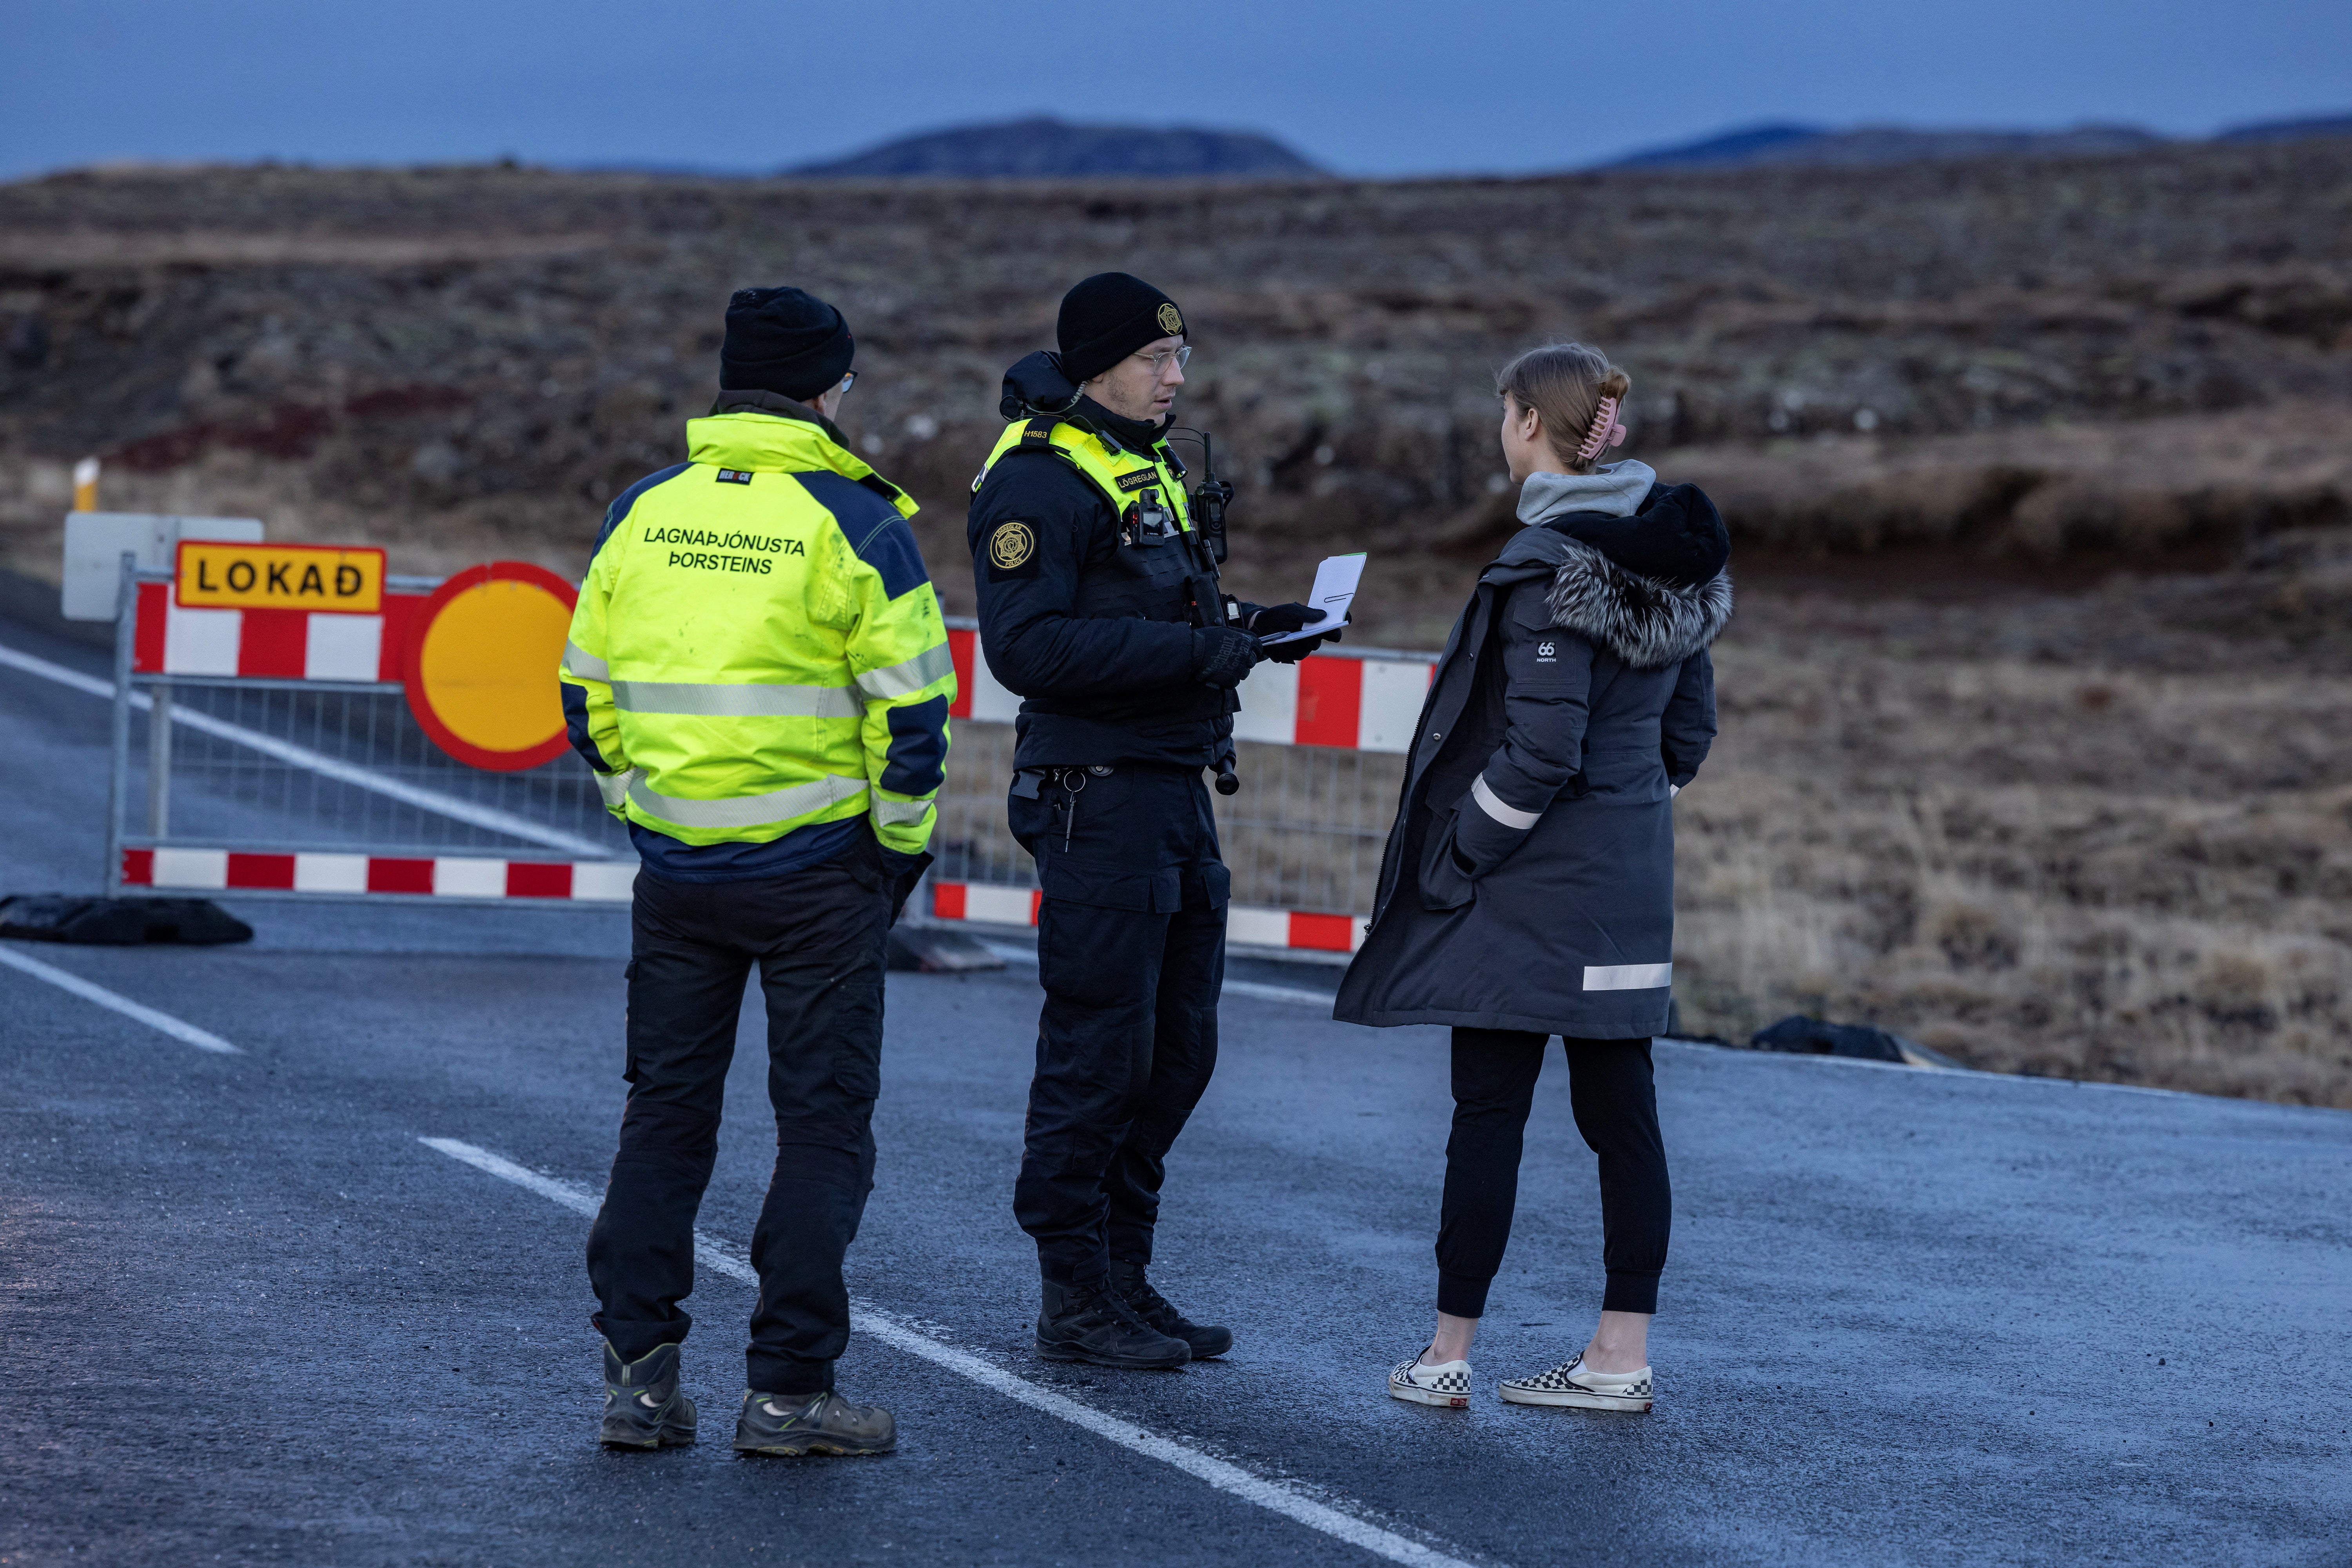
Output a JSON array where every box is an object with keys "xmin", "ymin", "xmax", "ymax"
[{"xmin": 0, "ymin": 141, "xmax": 2352, "ymax": 1105}]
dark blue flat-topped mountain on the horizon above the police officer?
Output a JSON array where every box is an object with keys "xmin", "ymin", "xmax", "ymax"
[{"xmin": 786, "ymin": 115, "xmax": 1322, "ymax": 179}]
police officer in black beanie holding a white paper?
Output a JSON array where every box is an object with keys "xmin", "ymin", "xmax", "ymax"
[{"xmin": 969, "ymin": 273, "xmax": 1312, "ymax": 1368}]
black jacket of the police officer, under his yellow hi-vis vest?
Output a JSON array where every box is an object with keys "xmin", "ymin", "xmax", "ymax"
[{"xmin": 964, "ymin": 407, "xmax": 1242, "ymax": 769}]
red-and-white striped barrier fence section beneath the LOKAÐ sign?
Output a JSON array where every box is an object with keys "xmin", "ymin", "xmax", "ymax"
[{"xmin": 106, "ymin": 571, "xmax": 637, "ymax": 905}]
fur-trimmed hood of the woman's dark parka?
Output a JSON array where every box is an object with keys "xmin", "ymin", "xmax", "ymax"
[{"xmin": 1489, "ymin": 484, "xmax": 1731, "ymax": 670}]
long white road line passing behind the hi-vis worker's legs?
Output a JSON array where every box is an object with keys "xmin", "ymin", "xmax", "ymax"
[{"xmin": 416, "ymin": 1138, "xmax": 1470, "ymax": 1568}]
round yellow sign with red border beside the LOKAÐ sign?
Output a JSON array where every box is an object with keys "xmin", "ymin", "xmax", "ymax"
[{"xmin": 402, "ymin": 562, "xmax": 579, "ymax": 773}]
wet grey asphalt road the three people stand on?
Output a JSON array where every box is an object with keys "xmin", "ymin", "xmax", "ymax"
[{"xmin": 0, "ymin": 606, "xmax": 2352, "ymax": 1568}]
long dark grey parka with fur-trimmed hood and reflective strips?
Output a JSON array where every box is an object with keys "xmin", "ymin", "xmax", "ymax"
[{"xmin": 1334, "ymin": 472, "xmax": 1731, "ymax": 1039}]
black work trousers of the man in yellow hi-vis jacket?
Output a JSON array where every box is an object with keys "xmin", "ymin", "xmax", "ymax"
[{"xmin": 588, "ymin": 844, "xmax": 891, "ymax": 1394}]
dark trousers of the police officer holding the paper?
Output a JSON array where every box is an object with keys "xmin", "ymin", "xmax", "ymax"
[{"xmin": 1011, "ymin": 764, "xmax": 1228, "ymax": 1283}]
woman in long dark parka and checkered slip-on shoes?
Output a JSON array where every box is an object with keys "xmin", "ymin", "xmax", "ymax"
[{"xmin": 1334, "ymin": 343, "xmax": 1731, "ymax": 1410}]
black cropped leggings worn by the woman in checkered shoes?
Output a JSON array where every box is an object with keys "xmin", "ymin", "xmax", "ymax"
[{"xmin": 1437, "ymin": 1030, "xmax": 1675, "ymax": 1316}]
